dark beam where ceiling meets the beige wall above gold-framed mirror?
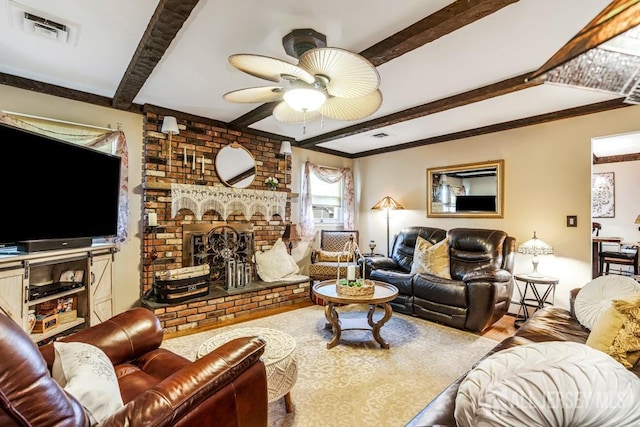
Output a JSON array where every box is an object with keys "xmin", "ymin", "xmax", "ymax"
[{"xmin": 350, "ymin": 98, "xmax": 631, "ymax": 158}]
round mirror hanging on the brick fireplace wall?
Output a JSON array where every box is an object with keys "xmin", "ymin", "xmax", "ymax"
[{"xmin": 216, "ymin": 142, "xmax": 256, "ymax": 188}]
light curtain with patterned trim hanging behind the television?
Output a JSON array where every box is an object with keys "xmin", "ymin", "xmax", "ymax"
[{"xmin": 0, "ymin": 111, "xmax": 129, "ymax": 243}]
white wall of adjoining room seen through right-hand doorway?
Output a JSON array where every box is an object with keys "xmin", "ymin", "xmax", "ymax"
[{"xmin": 593, "ymin": 161, "xmax": 640, "ymax": 244}]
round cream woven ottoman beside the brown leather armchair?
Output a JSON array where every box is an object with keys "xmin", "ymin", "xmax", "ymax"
[{"xmin": 196, "ymin": 328, "xmax": 298, "ymax": 412}]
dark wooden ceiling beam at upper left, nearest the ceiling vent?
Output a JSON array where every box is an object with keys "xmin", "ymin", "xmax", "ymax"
[{"xmin": 113, "ymin": 0, "xmax": 198, "ymax": 109}]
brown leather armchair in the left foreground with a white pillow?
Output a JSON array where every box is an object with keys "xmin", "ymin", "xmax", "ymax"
[{"xmin": 0, "ymin": 308, "xmax": 268, "ymax": 427}]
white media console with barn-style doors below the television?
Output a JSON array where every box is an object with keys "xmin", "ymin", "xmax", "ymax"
[{"xmin": 0, "ymin": 244, "xmax": 116, "ymax": 342}]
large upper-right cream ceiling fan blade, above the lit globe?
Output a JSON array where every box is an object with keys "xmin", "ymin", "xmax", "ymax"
[{"xmin": 298, "ymin": 47, "xmax": 380, "ymax": 98}]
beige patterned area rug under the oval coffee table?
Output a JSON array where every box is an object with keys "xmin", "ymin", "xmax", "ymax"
[{"xmin": 162, "ymin": 305, "xmax": 496, "ymax": 427}]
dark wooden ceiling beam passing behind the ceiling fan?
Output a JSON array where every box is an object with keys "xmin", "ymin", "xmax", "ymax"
[{"xmin": 232, "ymin": 0, "xmax": 519, "ymax": 126}]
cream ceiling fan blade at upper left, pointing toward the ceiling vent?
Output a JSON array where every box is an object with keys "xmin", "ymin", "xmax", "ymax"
[{"xmin": 229, "ymin": 53, "xmax": 315, "ymax": 84}]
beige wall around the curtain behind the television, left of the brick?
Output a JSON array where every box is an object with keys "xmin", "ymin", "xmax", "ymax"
[{"xmin": 0, "ymin": 85, "xmax": 143, "ymax": 313}]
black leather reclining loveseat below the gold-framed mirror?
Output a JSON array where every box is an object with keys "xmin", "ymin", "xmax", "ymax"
[{"xmin": 365, "ymin": 226, "xmax": 515, "ymax": 332}]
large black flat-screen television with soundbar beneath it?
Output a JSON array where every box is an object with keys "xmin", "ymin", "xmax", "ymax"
[{"xmin": 0, "ymin": 123, "xmax": 120, "ymax": 252}]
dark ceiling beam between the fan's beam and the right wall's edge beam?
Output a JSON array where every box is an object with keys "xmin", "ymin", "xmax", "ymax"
[{"xmin": 297, "ymin": 73, "xmax": 543, "ymax": 148}]
